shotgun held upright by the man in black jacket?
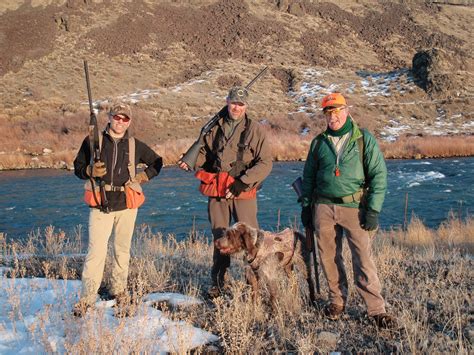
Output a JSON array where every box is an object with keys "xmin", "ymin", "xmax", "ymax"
[{"xmin": 84, "ymin": 60, "xmax": 109, "ymax": 213}]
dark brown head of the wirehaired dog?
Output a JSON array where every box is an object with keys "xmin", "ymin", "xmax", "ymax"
[{"xmin": 214, "ymin": 222, "xmax": 258, "ymax": 255}]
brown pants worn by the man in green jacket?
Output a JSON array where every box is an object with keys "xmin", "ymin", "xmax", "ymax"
[{"xmin": 313, "ymin": 204, "xmax": 385, "ymax": 316}]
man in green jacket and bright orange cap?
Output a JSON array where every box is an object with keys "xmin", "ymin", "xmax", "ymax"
[{"xmin": 301, "ymin": 93, "xmax": 396, "ymax": 328}]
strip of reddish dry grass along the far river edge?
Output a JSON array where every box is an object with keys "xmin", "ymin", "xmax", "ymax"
[{"xmin": 0, "ymin": 131, "xmax": 474, "ymax": 171}]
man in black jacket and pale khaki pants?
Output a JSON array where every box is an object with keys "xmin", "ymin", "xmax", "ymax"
[{"xmin": 74, "ymin": 104, "xmax": 163, "ymax": 316}]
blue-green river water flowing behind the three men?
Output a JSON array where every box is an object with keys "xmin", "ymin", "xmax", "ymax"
[{"xmin": 0, "ymin": 158, "xmax": 474, "ymax": 242}]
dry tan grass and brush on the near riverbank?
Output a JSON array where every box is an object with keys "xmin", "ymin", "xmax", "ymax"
[{"xmin": 0, "ymin": 216, "xmax": 474, "ymax": 353}]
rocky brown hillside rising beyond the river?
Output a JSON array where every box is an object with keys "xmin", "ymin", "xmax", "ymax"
[{"xmin": 0, "ymin": 0, "xmax": 474, "ymax": 167}]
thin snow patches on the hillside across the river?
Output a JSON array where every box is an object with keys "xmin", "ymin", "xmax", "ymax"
[{"xmin": 79, "ymin": 67, "xmax": 468, "ymax": 141}]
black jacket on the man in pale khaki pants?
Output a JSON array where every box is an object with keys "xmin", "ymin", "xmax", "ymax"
[{"xmin": 74, "ymin": 130, "xmax": 163, "ymax": 211}]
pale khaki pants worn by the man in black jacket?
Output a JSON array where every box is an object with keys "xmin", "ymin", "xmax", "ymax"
[{"xmin": 81, "ymin": 208, "xmax": 138, "ymax": 303}]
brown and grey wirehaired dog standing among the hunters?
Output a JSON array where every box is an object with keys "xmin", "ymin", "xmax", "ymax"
[{"xmin": 214, "ymin": 222, "xmax": 314, "ymax": 308}]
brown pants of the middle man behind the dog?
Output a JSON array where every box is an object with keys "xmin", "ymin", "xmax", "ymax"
[{"xmin": 208, "ymin": 197, "xmax": 258, "ymax": 286}]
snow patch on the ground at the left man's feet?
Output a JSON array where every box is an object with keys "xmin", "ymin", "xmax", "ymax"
[{"xmin": 0, "ymin": 276, "xmax": 218, "ymax": 354}]
